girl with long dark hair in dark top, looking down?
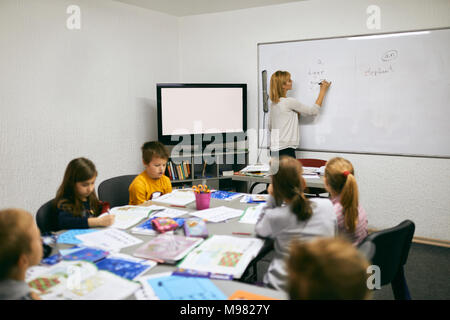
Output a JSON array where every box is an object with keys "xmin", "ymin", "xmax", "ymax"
[{"xmin": 55, "ymin": 158, "xmax": 114, "ymax": 229}]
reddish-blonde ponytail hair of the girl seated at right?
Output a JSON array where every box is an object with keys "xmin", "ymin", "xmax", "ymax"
[{"xmin": 325, "ymin": 157, "xmax": 359, "ymax": 232}]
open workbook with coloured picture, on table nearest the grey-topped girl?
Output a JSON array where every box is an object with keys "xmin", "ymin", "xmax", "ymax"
[{"xmin": 178, "ymin": 235, "xmax": 264, "ymax": 279}]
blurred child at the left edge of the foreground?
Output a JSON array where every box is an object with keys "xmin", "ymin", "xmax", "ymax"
[{"xmin": 0, "ymin": 209, "xmax": 43, "ymax": 300}]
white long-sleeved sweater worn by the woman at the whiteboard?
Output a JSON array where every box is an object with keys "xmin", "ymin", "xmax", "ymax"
[{"xmin": 269, "ymin": 98, "xmax": 320, "ymax": 151}]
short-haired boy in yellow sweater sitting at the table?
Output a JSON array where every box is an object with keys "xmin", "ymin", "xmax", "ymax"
[{"xmin": 128, "ymin": 141, "xmax": 172, "ymax": 205}]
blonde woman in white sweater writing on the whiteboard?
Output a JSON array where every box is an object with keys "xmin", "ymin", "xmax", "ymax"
[{"xmin": 269, "ymin": 71, "xmax": 330, "ymax": 158}]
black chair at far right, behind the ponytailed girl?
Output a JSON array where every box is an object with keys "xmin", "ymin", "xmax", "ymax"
[{"xmin": 358, "ymin": 220, "xmax": 415, "ymax": 300}]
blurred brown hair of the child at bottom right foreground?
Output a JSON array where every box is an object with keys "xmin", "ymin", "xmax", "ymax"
[{"xmin": 287, "ymin": 238, "xmax": 370, "ymax": 300}]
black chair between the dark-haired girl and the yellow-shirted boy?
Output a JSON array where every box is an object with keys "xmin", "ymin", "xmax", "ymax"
[{"xmin": 98, "ymin": 174, "xmax": 136, "ymax": 208}]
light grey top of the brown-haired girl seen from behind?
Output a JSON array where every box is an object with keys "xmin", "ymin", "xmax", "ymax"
[{"xmin": 255, "ymin": 196, "xmax": 337, "ymax": 290}]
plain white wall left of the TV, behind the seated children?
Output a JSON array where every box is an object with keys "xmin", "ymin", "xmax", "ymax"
[{"xmin": 0, "ymin": 0, "xmax": 179, "ymax": 213}]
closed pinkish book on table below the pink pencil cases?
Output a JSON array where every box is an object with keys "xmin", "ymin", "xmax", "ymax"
[{"xmin": 133, "ymin": 233, "xmax": 203, "ymax": 264}]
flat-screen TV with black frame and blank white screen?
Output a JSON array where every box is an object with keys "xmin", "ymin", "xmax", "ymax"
[{"xmin": 156, "ymin": 83, "xmax": 247, "ymax": 145}]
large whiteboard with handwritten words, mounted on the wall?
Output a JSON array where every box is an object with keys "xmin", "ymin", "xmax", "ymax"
[{"xmin": 258, "ymin": 29, "xmax": 450, "ymax": 158}]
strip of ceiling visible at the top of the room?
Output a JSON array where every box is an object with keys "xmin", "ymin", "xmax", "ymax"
[{"xmin": 113, "ymin": 0, "xmax": 305, "ymax": 17}]
